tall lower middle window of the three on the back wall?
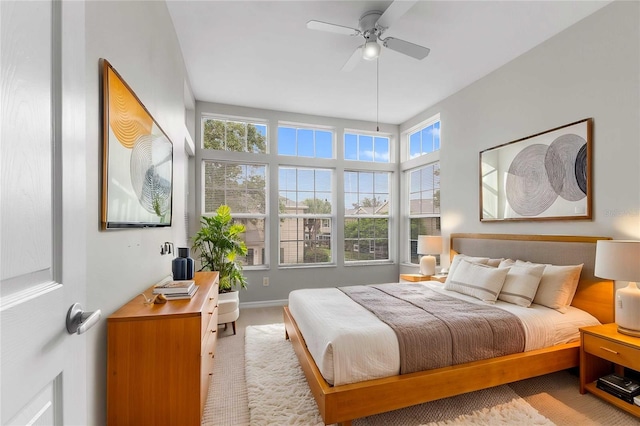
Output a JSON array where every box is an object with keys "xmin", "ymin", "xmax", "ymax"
[{"xmin": 278, "ymin": 167, "xmax": 333, "ymax": 265}]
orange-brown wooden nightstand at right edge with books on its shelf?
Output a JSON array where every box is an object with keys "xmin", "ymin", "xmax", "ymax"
[{"xmin": 580, "ymin": 324, "xmax": 640, "ymax": 417}]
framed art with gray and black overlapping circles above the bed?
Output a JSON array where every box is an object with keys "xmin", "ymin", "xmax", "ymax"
[{"xmin": 480, "ymin": 118, "xmax": 593, "ymax": 221}]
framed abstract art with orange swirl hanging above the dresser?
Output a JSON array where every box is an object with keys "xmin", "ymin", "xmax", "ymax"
[{"xmin": 101, "ymin": 59, "xmax": 173, "ymax": 229}]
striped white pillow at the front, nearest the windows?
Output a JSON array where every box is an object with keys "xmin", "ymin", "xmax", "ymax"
[{"xmin": 444, "ymin": 259, "xmax": 509, "ymax": 303}]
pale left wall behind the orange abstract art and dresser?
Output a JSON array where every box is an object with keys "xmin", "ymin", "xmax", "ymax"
[{"xmin": 84, "ymin": 1, "xmax": 193, "ymax": 425}]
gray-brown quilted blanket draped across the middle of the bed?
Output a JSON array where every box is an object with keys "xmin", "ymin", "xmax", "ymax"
[{"xmin": 339, "ymin": 284, "xmax": 525, "ymax": 374}]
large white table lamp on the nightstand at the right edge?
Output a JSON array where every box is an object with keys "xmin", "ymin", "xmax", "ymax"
[{"xmin": 594, "ymin": 240, "xmax": 640, "ymax": 337}]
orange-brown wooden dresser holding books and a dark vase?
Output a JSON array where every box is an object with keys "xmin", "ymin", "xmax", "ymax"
[{"xmin": 107, "ymin": 272, "xmax": 218, "ymax": 425}]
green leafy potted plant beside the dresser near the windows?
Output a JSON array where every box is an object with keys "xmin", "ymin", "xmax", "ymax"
[{"xmin": 193, "ymin": 205, "xmax": 247, "ymax": 293}]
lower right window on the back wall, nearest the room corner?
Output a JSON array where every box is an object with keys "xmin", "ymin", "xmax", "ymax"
[{"xmin": 344, "ymin": 171, "xmax": 391, "ymax": 262}]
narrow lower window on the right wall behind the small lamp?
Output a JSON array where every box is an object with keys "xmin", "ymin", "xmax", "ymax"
[{"xmin": 407, "ymin": 162, "xmax": 440, "ymax": 263}]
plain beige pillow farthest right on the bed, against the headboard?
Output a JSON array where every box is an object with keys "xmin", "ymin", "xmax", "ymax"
[{"xmin": 516, "ymin": 260, "xmax": 583, "ymax": 313}]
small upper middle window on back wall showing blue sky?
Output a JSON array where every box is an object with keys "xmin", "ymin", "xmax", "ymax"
[{"xmin": 278, "ymin": 126, "xmax": 333, "ymax": 158}]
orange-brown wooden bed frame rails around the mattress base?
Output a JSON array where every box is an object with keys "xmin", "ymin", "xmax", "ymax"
[{"xmin": 284, "ymin": 307, "xmax": 580, "ymax": 425}]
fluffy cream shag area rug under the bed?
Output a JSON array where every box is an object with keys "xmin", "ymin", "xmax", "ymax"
[{"xmin": 245, "ymin": 324, "xmax": 554, "ymax": 426}]
